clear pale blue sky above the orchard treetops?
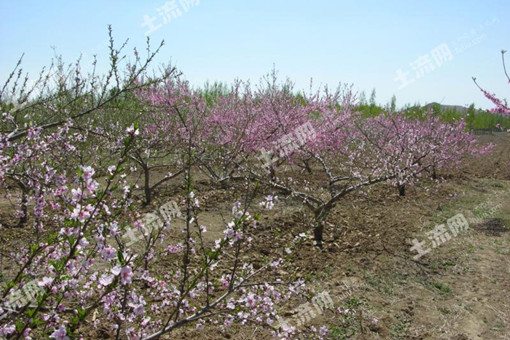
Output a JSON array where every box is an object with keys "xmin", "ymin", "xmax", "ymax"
[{"xmin": 0, "ymin": 0, "xmax": 510, "ymax": 108}]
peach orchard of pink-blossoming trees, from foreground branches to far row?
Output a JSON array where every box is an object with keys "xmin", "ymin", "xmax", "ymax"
[{"xmin": 0, "ymin": 31, "xmax": 508, "ymax": 339}]
